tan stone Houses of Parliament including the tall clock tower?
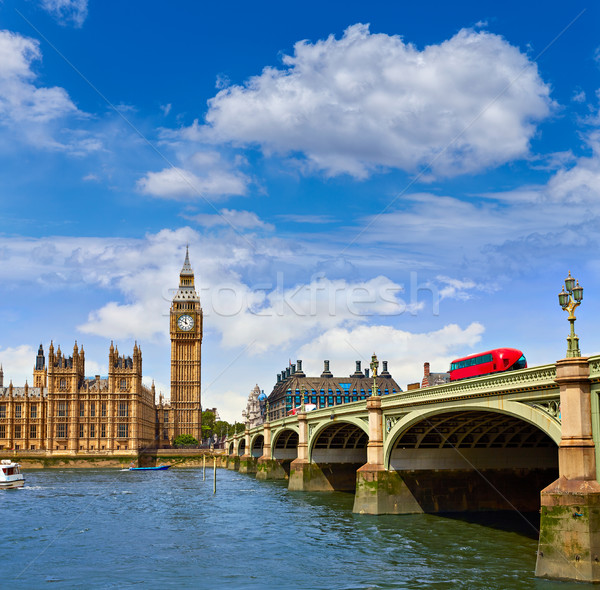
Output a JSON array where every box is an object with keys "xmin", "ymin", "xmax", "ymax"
[{"xmin": 0, "ymin": 250, "xmax": 202, "ymax": 455}]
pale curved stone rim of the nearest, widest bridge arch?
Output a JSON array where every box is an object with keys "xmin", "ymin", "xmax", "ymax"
[{"xmin": 383, "ymin": 399, "xmax": 561, "ymax": 469}]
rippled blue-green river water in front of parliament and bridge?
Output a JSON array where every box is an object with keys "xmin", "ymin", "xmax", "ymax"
[{"xmin": 0, "ymin": 469, "xmax": 585, "ymax": 590}]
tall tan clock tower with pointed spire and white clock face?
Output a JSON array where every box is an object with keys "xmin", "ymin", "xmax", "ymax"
[{"xmin": 169, "ymin": 248, "xmax": 202, "ymax": 442}]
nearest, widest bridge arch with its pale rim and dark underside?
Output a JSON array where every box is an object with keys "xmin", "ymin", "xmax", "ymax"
[{"xmin": 384, "ymin": 401, "xmax": 560, "ymax": 513}]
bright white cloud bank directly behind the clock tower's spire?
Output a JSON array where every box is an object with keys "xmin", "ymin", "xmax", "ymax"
[{"xmin": 71, "ymin": 242, "xmax": 422, "ymax": 354}]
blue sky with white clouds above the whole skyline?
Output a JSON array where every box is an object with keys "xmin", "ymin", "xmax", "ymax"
[{"xmin": 0, "ymin": 0, "xmax": 600, "ymax": 420}]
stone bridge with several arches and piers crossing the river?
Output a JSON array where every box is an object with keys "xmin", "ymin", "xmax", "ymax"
[{"xmin": 226, "ymin": 355, "xmax": 600, "ymax": 581}]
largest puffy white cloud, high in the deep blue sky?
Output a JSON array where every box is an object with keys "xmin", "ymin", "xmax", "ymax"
[{"xmin": 203, "ymin": 24, "xmax": 552, "ymax": 178}]
